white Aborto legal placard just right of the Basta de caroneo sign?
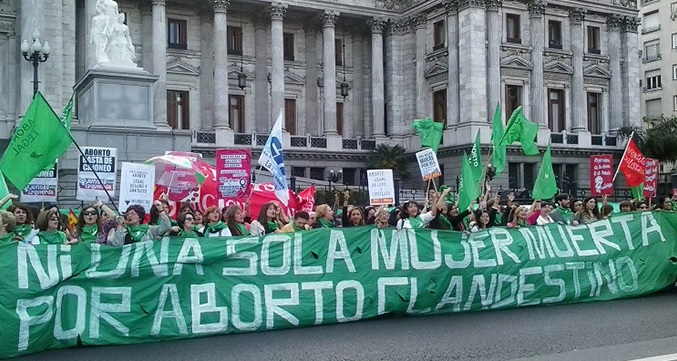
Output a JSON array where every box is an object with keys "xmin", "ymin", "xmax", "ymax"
[{"xmin": 118, "ymin": 162, "xmax": 155, "ymax": 212}]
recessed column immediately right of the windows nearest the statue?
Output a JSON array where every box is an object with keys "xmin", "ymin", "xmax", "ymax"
[{"xmin": 200, "ymin": 10, "xmax": 215, "ymax": 130}]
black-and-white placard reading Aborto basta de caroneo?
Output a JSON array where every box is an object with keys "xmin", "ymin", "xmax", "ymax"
[{"xmin": 76, "ymin": 147, "xmax": 118, "ymax": 202}]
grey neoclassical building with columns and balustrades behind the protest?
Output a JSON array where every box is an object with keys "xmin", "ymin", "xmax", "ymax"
[{"xmin": 0, "ymin": 0, "xmax": 641, "ymax": 197}]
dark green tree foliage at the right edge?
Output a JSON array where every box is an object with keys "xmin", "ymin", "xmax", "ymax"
[{"xmin": 620, "ymin": 116, "xmax": 677, "ymax": 163}]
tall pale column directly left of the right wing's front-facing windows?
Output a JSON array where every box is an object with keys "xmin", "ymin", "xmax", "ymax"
[{"xmin": 486, "ymin": 0, "xmax": 502, "ymax": 120}]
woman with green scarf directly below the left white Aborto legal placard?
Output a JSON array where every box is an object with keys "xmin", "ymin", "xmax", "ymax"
[{"xmin": 108, "ymin": 200, "xmax": 172, "ymax": 247}]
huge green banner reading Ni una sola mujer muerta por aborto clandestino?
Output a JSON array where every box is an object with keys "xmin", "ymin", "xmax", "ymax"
[{"xmin": 0, "ymin": 213, "xmax": 677, "ymax": 357}]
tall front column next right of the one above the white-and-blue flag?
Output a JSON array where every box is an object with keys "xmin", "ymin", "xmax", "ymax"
[{"xmin": 322, "ymin": 10, "xmax": 339, "ymax": 135}]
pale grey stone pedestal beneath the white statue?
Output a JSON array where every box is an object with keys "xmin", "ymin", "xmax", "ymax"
[{"xmin": 75, "ymin": 65, "xmax": 158, "ymax": 129}]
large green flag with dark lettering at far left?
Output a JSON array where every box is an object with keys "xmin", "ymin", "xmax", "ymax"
[{"xmin": 0, "ymin": 92, "xmax": 72, "ymax": 189}]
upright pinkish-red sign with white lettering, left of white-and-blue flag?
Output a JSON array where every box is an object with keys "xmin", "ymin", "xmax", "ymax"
[{"xmin": 216, "ymin": 149, "xmax": 252, "ymax": 199}]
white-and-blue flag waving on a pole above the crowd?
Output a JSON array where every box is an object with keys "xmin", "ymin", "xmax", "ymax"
[{"xmin": 259, "ymin": 112, "xmax": 289, "ymax": 207}]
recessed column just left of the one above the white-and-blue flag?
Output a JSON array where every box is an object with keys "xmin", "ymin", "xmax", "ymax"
[{"xmin": 254, "ymin": 14, "xmax": 271, "ymax": 134}]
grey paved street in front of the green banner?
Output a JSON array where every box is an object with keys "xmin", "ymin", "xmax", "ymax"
[{"xmin": 11, "ymin": 293, "xmax": 677, "ymax": 361}]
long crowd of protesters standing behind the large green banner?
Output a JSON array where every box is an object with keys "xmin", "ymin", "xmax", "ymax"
[{"xmin": 0, "ymin": 185, "xmax": 677, "ymax": 246}]
